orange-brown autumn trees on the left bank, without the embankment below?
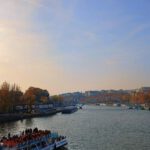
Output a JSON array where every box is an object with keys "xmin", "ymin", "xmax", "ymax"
[{"xmin": 0, "ymin": 82, "xmax": 63, "ymax": 114}]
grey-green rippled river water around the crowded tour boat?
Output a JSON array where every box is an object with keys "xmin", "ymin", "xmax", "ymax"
[{"xmin": 0, "ymin": 106, "xmax": 150, "ymax": 150}]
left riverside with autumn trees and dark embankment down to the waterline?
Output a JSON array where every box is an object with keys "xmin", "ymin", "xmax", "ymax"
[{"xmin": 0, "ymin": 82, "xmax": 63, "ymax": 123}]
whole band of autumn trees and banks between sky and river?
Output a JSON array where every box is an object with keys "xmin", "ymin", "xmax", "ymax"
[{"xmin": 0, "ymin": 82, "xmax": 150, "ymax": 123}]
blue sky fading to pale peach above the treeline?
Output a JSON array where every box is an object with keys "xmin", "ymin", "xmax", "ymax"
[{"xmin": 0, "ymin": 0, "xmax": 150, "ymax": 95}]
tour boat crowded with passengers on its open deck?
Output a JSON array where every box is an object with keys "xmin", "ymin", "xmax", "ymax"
[{"xmin": 0, "ymin": 128, "xmax": 67, "ymax": 150}]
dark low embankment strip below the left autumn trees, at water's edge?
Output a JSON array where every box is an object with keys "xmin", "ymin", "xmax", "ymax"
[{"xmin": 0, "ymin": 110, "xmax": 58, "ymax": 123}]
